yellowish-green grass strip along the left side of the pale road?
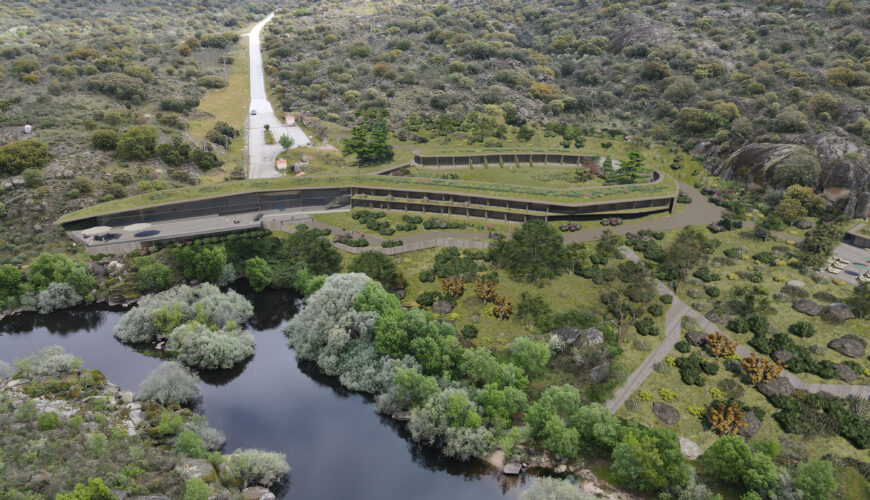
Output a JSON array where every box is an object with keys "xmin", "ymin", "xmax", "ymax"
[{"xmin": 187, "ymin": 37, "xmax": 251, "ymax": 184}]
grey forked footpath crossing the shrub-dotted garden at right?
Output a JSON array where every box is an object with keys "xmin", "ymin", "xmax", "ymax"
[{"xmin": 605, "ymin": 247, "xmax": 870, "ymax": 413}]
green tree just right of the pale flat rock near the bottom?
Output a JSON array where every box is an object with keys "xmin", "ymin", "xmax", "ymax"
[{"xmin": 700, "ymin": 435, "xmax": 779, "ymax": 490}]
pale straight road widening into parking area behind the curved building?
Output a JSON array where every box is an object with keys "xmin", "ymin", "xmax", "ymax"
[{"xmin": 245, "ymin": 13, "xmax": 311, "ymax": 179}]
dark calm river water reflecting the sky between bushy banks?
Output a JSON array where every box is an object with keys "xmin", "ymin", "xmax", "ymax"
[{"xmin": 0, "ymin": 290, "xmax": 528, "ymax": 500}]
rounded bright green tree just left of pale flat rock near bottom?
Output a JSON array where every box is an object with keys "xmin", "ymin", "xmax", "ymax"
[{"xmin": 610, "ymin": 429, "xmax": 689, "ymax": 492}]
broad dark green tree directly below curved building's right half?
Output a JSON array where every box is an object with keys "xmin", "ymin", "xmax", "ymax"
[{"xmin": 490, "ymin": 219, "xmax": 567, "ymax": 283}]
